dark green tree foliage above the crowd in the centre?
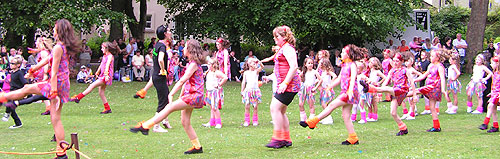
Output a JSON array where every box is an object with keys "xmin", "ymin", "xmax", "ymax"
[{"xmin": 158, "ymin": 0, "xmax": 421, "ymax": 51}]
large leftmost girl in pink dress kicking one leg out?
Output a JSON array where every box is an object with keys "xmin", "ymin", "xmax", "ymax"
[{"xmin": 0, "ymin": 19, "xmax": 81, "ymax": 158}]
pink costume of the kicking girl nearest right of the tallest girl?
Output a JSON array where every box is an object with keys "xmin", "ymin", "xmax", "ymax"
[{"xmin": 339, "ymin": 62, "xmax": 359, "ymax": 104}]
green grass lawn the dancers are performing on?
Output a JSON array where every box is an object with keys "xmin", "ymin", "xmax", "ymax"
[{"xmin": 0, "ymin": 75, "xmax": 500, "ymax": 159}]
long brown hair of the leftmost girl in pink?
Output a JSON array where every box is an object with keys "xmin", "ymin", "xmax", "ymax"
[{"xmin": 55, "ymin": 19, "xmax": 82, "ymax": 55}]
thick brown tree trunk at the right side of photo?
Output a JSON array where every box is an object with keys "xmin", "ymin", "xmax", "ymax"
[{"xmin": 465, "ymin": 0, "xmax": 489, "ymax": 73}]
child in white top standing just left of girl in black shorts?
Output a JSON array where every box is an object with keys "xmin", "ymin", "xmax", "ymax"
[{"xmin": 241, "ymin": 58, "xmax": 264, "ymax": 127}]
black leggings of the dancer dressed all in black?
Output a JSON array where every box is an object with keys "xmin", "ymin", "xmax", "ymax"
[{"xmin": 152, "ymin": 75, "xmax": 170, "ymax": 112}]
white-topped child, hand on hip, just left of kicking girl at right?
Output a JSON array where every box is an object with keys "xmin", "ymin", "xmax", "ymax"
[{"xmin": 366, "ymin": 57, "xmax": 386, "ymax": 122}]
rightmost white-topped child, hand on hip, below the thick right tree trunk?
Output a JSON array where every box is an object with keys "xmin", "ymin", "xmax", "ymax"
[{"xmin": 467, "ymin": 55, "xmax": 492, "ymax": 114}]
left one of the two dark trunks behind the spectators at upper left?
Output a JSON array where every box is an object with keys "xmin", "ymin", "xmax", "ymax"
[{"xmin": 108, "ymin": 0, "xmax": 126, "ymax": 41}]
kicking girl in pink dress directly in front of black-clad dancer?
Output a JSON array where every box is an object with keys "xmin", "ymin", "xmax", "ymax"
[{"xmin": 130, "ymin": 40, "xmax": 206, "ymax": 154}]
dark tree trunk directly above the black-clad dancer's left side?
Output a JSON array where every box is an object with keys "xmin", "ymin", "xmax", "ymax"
[{"xmin": 125, "ymin": 0, "xmax": 147, "ymax": 40}]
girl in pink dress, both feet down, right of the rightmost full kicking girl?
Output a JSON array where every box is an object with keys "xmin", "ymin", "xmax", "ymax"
[{"xmin": 415, "ymin": 50, "xmax": 446, "ymax": 132}]
